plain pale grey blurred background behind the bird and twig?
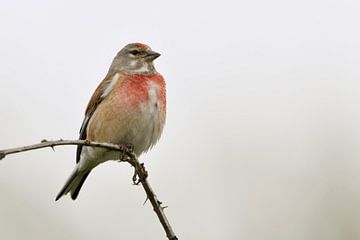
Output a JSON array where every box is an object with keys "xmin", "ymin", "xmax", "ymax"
[{"xmin": 0, "ymin": 0, "xmax": 360, "ymax": 240}]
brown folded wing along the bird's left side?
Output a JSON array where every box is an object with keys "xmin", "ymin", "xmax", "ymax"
[{"xmin": 76, "ymin": 73, "xmax": 120, "ymax": 163}]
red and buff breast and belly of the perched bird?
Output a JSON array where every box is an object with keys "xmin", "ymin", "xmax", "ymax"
[{"xmin": 87, "ymin": 73, "xmax": 166, "ymax": 149}]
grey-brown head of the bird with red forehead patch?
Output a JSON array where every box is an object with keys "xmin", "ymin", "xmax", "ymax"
[{"xmin": 110, "ymin": 43, "xmax": 160, "ymax": 74}]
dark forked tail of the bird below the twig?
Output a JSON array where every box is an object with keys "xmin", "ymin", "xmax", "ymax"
[{"xmin": 55, "ymin": 168, "xmax": 91, "ymax": 201}]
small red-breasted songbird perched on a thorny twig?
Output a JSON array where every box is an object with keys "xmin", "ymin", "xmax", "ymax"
[{"xmin": 56, "ymin": 43, "xmax": 166, "ymax": 200}]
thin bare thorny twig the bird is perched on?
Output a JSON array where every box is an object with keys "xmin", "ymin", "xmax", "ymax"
[{"xmin": 0, "ymin": 139, "xmax": 178, "ymax": 240}]
